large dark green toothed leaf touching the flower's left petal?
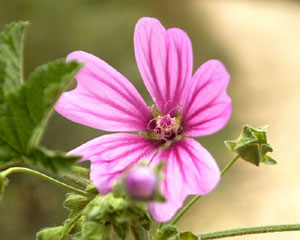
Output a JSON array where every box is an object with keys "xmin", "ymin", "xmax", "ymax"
[{"xmin": 0, "ymin": 60, "xmax": 80, "ymax": 173}]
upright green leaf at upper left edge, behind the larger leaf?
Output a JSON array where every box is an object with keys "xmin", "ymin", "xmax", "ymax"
[{"xmin": 0, "ymin": 21, "xmax": 28, "ymax": 99}]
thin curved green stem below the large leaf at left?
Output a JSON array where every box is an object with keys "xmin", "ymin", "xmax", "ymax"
[{"xmin": 0, "ymin": 167, "xmax": 89, "ymax": 196}]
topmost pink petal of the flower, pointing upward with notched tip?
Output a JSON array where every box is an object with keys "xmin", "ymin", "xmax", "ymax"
[{"xmin": 134, "ymin": 17, "xmax": 193, "ymax": 114}]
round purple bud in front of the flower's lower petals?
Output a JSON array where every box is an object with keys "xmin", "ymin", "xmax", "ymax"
[{"xmin": 125, "ymin": 166, "xmax": 158, "ymax": 201}]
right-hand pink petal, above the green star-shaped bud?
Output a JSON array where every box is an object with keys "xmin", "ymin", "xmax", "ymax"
[{"xmin": 182, "ymin": 60, "xmax": 231, "ymax": 137}]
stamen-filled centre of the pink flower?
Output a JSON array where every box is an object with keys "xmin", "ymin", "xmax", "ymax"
[{"xmin": 148, "ymin": 107, "xmax": 182, "ymax": 141}]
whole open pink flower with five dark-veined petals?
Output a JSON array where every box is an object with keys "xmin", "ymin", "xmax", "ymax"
[{"xmin": 56, "ymin": 17, "xmax": 231, "ymax": 221}]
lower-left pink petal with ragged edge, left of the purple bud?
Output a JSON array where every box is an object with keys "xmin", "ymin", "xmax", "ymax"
[{"xmin": 68, "ymin": 133, "xmax": 159, "ymax": 194}]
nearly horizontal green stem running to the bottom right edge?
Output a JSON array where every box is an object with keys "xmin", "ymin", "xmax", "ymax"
[{"xmin": 199, "ymin": 224, "xmax": 300, "ymax": 240}]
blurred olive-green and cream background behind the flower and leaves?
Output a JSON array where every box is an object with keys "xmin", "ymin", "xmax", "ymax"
[{"xmin": 0, "ymin": 0, "xmax": 300, "ymax": 240}]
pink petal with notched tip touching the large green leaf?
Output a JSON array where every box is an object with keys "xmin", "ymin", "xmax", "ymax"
[{"xmin": 55, "ymin": 51, "xmax": 151, "ymax": 131}]
